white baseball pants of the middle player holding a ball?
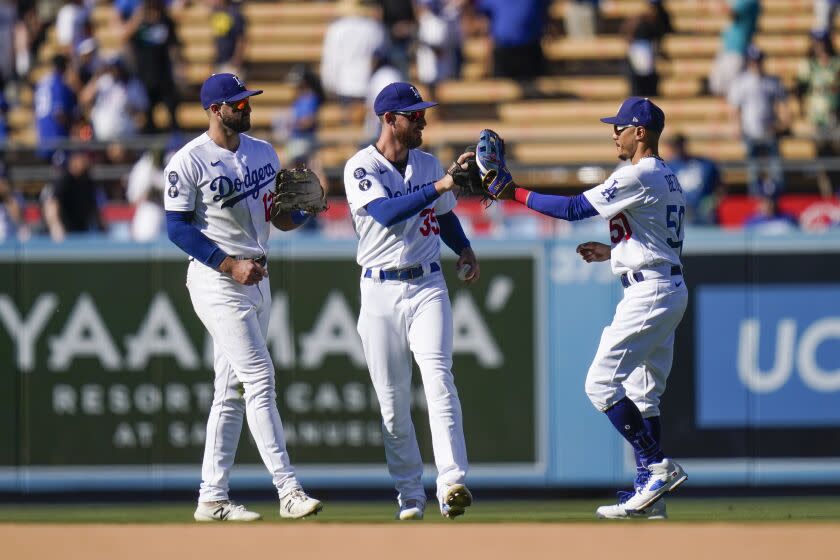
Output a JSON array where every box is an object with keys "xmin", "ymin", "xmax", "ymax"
[{"xmin": 358, "ymin": 269, "xmax": 468, "ymax": 505}]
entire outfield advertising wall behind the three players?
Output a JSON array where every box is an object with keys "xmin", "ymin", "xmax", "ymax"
[{"xmin": 0, "ymin": 230, "xmax": 840, "ymax": 492}]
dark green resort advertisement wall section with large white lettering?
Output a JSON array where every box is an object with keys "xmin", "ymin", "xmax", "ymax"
[{"xmin": 0, "ymin": 243, "xmax": 546, "ymax": 488}]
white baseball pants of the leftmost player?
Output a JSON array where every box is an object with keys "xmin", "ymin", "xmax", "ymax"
[{"xmin": 187, "ymin": 261, "xmax": 299, "ymax": 502}]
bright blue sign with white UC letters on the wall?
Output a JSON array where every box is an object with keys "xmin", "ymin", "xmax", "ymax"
[{"xmin": 696, "ymin": 284, "xmax": 840, "ymax": 427}]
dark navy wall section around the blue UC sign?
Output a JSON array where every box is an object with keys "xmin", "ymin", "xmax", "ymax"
[{"xmin": 663, "ymin": 245, "xmax": 840, "ymax": 484}]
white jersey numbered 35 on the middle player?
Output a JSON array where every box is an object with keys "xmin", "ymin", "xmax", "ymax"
[{"xmin": 344, "ymin": 146, "xmax": 456, "ymax": 269}]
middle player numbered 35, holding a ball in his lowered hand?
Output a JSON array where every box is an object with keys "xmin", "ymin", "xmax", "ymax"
[{"xmin": 344, "ymin": 82, "xmax": 480, "ymax": 520}]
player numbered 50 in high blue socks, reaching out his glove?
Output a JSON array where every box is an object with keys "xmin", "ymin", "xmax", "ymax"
[{"xmin": 508, "ymin": 97, "xmax": 688, "ymax": 519}]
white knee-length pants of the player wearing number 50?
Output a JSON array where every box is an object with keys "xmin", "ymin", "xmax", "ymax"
[{"xmin": 586, "ymin": 275, "xmax": 688, "ymax": 418}]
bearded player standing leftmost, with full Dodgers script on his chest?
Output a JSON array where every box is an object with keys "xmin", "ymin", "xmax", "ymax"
[{"xmin": 164, "ymin": 74, "xmax": 322, "ymax": 521}]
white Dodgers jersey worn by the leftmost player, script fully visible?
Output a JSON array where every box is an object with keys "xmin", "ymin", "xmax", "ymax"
[{"xmin": 163, "ymin": 132, "xmax": 280, "ymax": 257}]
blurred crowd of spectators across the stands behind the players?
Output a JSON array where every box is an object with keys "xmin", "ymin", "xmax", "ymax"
[{"xmin": 0, "ymin": 0, "xmax": 840, "ymax": 240}]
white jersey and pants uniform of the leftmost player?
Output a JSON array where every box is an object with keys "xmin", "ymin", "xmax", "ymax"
[{"xmin": 163, "ymin": 133, "xmax": 300, "ymax": 502}]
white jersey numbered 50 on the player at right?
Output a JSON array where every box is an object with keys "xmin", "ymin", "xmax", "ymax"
[{"xmin": 583, "ymin": 157, "xmax": 685, "ymax": 275}]
